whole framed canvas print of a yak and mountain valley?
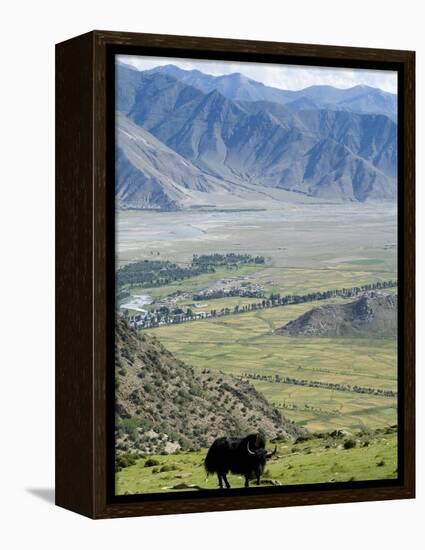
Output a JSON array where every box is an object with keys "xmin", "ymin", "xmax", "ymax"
[{"xmin": 56, "ymin": 31, "xmax": 415, "ymax": 518}]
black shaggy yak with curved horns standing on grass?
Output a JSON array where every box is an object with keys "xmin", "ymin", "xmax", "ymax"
[{"xmin": 204, "ymin": 433, "xmax": 277, "ymax": 489}]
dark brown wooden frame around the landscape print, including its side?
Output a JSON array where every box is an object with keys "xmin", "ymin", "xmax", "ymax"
[{"xmin": 56, "ymin": 31, "xmax": 415, "ymax": 518}]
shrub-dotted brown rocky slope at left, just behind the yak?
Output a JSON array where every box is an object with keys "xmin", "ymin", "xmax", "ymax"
[{"xmin": 115, "ymin": 318, "xmax": 305, "ymax": 453}]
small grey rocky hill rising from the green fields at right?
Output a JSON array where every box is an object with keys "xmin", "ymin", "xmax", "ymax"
[{"xmin": 276, "ymin": 292, "xmax": 397, "ymax": 338}]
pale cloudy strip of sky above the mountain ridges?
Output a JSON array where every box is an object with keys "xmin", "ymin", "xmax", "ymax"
[{"xmin": 118, "ymin": 55, "xmax": 397, "ymax": 93}]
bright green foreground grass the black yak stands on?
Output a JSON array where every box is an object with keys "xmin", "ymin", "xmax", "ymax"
[{"xmin": 116, "ymin": 430, "xmax": 397, "ymax": 494}]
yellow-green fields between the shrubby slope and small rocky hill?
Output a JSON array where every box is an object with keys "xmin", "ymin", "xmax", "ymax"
[{"xmin": 152, "ymin": 300, "xmax": 397, "ymax": 430}]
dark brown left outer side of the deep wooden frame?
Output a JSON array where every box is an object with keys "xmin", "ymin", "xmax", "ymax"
[{"xmin": 55, "ymin": 33, "xmax": 96, "ymax": 517}]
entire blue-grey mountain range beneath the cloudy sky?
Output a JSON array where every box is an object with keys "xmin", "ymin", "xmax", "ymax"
[{"xmin": 116, "ymin": 64, "xmax": 397, "ymax": 210}]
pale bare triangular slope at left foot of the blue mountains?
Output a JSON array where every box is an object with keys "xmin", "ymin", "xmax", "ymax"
[{"xmin": 116, "ymin": 113, "xmax": 317, "ymax": 211}]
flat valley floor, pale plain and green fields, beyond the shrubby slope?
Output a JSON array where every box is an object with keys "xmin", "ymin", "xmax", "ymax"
[{"xmin": 118, "ymin": 204, "xmax": 397, "ymax": 431}]
